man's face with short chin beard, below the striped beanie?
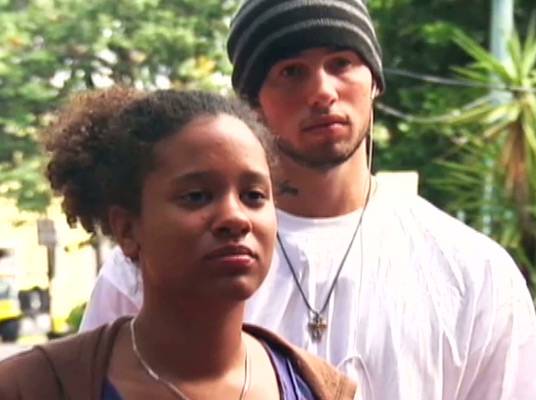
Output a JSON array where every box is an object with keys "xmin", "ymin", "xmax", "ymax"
[{"xmin": 259, "ymin": 48, "xmax": 373, "ymax": 169}]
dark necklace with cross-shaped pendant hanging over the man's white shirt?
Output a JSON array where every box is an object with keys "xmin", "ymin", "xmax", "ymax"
[{"xmin": 277, "ymin": 176, "xmax": 372, "ymax": 342}]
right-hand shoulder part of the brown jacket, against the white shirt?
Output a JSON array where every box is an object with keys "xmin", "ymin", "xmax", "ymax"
[{"xmin": 244, "ymin": 325, "xmax": 357, "ymax": 400}]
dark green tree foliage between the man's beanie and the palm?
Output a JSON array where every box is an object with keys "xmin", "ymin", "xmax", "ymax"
[{"xmin": 368, "ymin": 0, "xmax": 534, "ymax": 208}]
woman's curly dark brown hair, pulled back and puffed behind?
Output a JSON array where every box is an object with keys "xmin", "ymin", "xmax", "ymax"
[{"xmin": 43, "ymin": 87, "xmax": 274, "ymax": 236}]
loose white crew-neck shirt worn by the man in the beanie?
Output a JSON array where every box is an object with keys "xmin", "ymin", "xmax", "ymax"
[{"xmin": 82, "ymin": 186, "xmax": 536, "ymax": 400}]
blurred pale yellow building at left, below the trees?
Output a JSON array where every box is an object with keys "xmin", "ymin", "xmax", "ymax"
[{"xmin": 0, "ymin": 198, "xmax": 110, "ymax": 331}]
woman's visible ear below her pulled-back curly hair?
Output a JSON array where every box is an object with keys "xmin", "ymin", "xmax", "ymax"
[{"xmin": 108, "ymin": 206, "xmax": 140, "ymax": 261}]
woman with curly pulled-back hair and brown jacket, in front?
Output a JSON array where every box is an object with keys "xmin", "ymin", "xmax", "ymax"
[{"xmin": 0, "ymin": 88, "xmax": 355, "ymax": 400}]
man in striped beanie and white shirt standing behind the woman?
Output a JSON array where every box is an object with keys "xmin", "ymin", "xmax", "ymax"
[{"xmin": 80, "ymin": 0, "xmax": 536, "ymax": 400}]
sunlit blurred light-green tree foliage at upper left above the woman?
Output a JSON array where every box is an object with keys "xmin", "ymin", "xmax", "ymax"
[{"xmin": 0, "ymin": 0, "xmax": 237, "ymax": 210}]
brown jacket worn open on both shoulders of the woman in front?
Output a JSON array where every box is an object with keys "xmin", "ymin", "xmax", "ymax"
[{"xmin": 0, "ymin": 317, "xmax": 356, "ymax": 400}]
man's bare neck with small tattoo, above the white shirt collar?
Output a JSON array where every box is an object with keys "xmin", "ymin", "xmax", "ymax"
[{"xmin": 274, "ymin": 145, "xmax": 370, "ymax": 218}]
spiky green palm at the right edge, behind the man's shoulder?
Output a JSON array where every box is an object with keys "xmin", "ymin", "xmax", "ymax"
[{"xmin": 436, "ymin": 16, "xmax": 536, "ymax": 289}]
